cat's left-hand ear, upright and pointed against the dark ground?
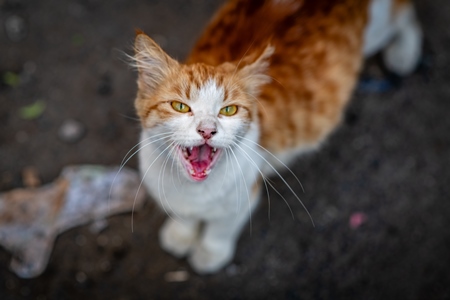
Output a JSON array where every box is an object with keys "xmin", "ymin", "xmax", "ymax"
[{"xmin": 133, "ymin": 31, "xmax": 179, "ymax": 92}]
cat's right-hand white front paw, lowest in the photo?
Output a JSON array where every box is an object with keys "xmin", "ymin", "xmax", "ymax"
[{"xmin": 189, "ymin": 242, "xmax": 235, "ymax": 274}]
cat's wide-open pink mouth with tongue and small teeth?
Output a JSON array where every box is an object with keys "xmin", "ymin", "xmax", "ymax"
[{"xmin": 178, "ymin": 144, "xmax": 222, "ymax": 182}]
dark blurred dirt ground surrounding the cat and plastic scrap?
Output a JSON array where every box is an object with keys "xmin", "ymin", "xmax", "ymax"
[{"xmin": 0, "ymin": 0, "xmax": 450, "ymax": 300}]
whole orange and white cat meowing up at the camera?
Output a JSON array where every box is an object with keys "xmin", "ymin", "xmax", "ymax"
[{"xmin": 133, "ymin": 0, "xmax": 422, "ymax": 274}]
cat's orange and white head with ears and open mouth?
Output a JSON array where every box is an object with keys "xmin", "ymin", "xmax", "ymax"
[{"xmin": 130, "ymin": 33, "xmax": 273, "ymax": 181}]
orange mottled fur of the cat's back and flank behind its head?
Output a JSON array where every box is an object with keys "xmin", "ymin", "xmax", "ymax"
[{"xmin": 187, "ymin": 0, "xmax": 369, "ymax": 153}]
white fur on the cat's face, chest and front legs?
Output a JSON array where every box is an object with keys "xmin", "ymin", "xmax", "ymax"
[{"xmin": 139, "ymin": 80, "xmax": 261, "ymax": 273}]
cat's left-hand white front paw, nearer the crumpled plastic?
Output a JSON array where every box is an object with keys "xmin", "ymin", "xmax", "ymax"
[{"xmin": 159, "ymin": 219, "xmax": 198, "ymax": 258}]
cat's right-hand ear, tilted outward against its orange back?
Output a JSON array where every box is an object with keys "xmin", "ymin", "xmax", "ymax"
[{"xmin": 239, "ymin": 45, "xmax": 275, "ymax": 95}]
